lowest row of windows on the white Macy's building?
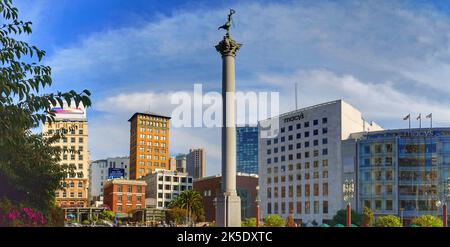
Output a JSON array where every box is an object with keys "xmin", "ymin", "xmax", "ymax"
[{"xmin": 267, "ymin": 201, "xmax": 328, "ymax": 214}]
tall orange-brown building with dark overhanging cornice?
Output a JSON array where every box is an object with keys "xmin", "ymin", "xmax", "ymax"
[{"xmin": 128, "ymin": 113, "xmax": 170, "ymax": 179}]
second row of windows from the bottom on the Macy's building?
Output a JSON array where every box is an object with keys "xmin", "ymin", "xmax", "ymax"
[{"xmin": 266, "ymin": 183, "xmax": 328, "ymax": 199}]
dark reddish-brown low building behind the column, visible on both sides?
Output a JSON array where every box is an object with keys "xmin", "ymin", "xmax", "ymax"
[{"xmin": 194, "ymin": 172, "xmax": 258, "ymax": 222}]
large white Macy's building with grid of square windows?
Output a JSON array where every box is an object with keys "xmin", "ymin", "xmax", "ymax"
[{"xmin": 258, "ymin": 100, "xmax": 382, "ymax": 224}]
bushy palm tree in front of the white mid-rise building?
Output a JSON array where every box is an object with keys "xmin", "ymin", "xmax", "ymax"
[{"xmin": 169, "ymin": 190, "xmax": 203, "ymax": 226}]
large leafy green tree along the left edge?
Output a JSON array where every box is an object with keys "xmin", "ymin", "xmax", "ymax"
[{"xmin": 0, "ymin": 0, "xmax": 91, "ymax": 212}]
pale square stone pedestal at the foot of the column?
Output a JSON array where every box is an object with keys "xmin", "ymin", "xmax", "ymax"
[{"xmin": 216, "ymin": 195, "xmax": 241, "ymax": 227}]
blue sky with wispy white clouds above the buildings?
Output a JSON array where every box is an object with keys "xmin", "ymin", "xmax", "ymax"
[{"xmin": 15, "ymin": 0, "xmax": 450, "ymax": 175}]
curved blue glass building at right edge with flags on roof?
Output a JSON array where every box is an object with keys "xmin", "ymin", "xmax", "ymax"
[{"xmin": 357, "ymin": 128, "xmax": 450, "ymax": 222}]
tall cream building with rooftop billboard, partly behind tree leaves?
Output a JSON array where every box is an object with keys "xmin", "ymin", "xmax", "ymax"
[{"xmin": 43, "ymin": 105, "xmax": 89, "ymax": 207}]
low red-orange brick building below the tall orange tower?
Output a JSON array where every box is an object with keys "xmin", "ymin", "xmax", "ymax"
[{"xmin": 103, "ymin": 179, "xmax": 147, "ymax": 214}]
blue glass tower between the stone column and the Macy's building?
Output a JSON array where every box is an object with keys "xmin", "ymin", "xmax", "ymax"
[{"xmin": 236, "ymin": 127, "xmax": 258, "ymax": 174}]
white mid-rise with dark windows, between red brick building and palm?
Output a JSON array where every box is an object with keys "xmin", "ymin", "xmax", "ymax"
[{"xmin": 141, "ymin": 169, "xmax": 193, "ymax": 209}]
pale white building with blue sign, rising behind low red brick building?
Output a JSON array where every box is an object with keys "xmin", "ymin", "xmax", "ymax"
[{"xmin": 89, "ymin": 157, "xmax": 130, "ymax": 206}]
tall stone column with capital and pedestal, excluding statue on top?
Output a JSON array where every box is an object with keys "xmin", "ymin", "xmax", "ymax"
[{"xmin": 216, "ymin": 32, "xmax": 241, "ymax": 227}]
